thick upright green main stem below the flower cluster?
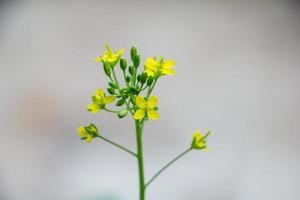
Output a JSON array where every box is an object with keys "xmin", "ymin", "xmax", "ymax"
[{"xmin": 135, "ymin": 121, "xmax": 146, "ymax": 200}]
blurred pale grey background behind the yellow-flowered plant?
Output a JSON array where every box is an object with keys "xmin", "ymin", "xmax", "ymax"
[{"xmin": 0, "ymin": 0, "xmax": 300, "ymax": 200}]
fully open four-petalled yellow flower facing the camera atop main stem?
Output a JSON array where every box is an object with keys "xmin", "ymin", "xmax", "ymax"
[{"xmin": 133, "ymin": 95, "xmax": 159, "ymax": 120}]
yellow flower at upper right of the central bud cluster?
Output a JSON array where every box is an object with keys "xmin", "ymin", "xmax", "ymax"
[{"xmin": 145, "ymin": 57, "xmax": 175, "ymax": 76}]
